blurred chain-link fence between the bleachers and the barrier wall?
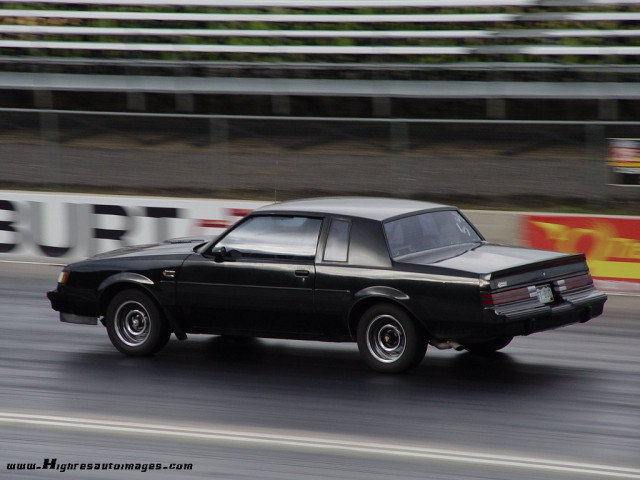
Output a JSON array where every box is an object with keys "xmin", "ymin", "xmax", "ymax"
[{"xmin": 0, "ymin": 109, "xmax": 640, "ymax": 209}]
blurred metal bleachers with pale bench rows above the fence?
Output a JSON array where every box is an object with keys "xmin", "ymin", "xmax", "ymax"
[{"xmin": 0, "ymin": 0, "xmax": 640, "ymax": 120}]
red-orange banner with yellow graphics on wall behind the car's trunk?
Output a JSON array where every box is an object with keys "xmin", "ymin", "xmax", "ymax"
[{"xmin": 521, "ymin": 215, "xmax": 640, "ymax": 282}]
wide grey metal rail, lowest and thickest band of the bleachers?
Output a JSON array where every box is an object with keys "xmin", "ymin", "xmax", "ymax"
[{"xmin": 5, "ymin": 72, "xmax": 640, "ymax": 100}]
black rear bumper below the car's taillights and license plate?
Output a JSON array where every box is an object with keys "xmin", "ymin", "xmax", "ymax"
[{"xmin": 494, "ymin": 290, "xmax": 607, "ymax": 336}]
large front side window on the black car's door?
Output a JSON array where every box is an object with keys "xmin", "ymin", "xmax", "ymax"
[{"xmin": 217, "ymin": 215, "xmax": 322, "ymax": 257}]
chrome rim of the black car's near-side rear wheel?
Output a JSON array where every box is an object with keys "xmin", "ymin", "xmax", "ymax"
[{"xmin": 367, "ymin": 315, "xmax": 407, "ymax": 363}]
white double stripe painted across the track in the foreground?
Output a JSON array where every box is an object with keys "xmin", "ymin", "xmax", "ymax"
[{"xmin": 0, "ymin": 412, "xmax": 640, "ymax": 480}]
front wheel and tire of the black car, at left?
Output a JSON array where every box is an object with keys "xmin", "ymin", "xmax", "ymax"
[{"xmin": 105, "ymin": 290, "xmax": 171, "ymax": 356}]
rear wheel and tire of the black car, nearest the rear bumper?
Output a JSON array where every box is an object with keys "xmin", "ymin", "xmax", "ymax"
[{"xmin": 357, "ymin": 303, "xmax": 428, "ymax": 373}]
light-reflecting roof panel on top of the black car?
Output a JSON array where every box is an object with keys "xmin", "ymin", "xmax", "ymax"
[{"xmin": 255, "ymin": 197, "xmax": 451, "ymax": 221}]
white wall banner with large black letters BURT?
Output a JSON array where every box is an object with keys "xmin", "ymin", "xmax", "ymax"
[{"xmin": 0, "ymin": 191, "xmax": 265, "ymax": 264}]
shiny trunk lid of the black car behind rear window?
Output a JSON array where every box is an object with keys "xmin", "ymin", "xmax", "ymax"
[{"xmin": 400, "ymin": 243, "xmax": 568, "ymax": 275}]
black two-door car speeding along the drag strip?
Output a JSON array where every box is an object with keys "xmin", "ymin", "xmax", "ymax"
[{"xmin": 48, "ymin": 197, "xmax": 607, "ymax": 372}]
